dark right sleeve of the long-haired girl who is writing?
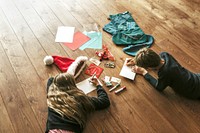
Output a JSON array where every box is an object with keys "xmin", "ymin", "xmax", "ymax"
[{"xmin": 91, "ymin": 85, "xmax": 110, "ymax": 110}]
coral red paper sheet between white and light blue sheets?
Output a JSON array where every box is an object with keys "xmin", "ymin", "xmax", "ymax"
[{"xmin": 64, "ymin": 31, "xmax": 90, "ymax": 50}]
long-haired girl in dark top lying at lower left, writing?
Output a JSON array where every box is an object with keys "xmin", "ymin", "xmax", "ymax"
[{"xmin": 46, "ymin": 73, "xmax": 110, "ymax": 133}]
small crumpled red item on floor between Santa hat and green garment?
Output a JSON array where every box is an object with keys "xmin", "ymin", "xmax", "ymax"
[{"xmin": 96, "ymin": 45, "xmax": 115, "ymax": 61}]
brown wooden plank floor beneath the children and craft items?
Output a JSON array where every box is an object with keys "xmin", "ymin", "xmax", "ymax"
[{"xmin": 0, "ymin": 0, "xmax": 200, "ymax": 133}]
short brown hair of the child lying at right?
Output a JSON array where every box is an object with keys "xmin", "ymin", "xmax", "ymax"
[{"xmin": 134, "ymin": 48, "xmax": 161, "ymax": 68}]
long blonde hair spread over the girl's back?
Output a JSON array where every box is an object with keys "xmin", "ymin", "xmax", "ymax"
[{"xmin": 47, "ymin": 73, "xmax": 94, "ymax": 128}]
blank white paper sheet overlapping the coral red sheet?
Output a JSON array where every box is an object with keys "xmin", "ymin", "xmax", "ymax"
[{"xmin": 55, "ymin": 26, "xmax": 75, "ymax": 43}]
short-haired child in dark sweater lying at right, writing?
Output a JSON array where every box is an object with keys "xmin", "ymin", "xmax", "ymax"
[{"xmin": 126, "ymin": 48, "xmax": 200, "ymax": 99}]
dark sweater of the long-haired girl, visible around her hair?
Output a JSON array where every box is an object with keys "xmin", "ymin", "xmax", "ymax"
[{"xmin": 45, "ymin": 78, "xmax": 110, "ymax": 133}]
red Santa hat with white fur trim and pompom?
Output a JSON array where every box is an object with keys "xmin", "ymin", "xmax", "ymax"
[{"xmin": 43, "ymin": 55, "xmax": 88, "ymax": 78}]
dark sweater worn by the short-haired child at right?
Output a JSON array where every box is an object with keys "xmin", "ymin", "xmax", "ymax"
[{"xmin": 144, "ymin": 52, "xmax": 200, "ymax": 99}]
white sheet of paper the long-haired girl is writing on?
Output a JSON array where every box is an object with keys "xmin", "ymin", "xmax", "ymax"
[{"xmin": 76, "ymin": 78, "xmax": 96, "ymax": 94}]
